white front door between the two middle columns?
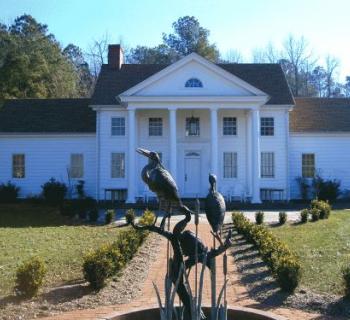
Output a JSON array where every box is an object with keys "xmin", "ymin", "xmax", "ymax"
[{"xmin": 185, "ymin": 151, "xmax": 201, "ymax": 197}]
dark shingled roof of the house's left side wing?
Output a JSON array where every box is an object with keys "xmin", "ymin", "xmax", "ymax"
[{"xmin": 0, "ymin": 99, "xmax": 96, "ymax": 133}]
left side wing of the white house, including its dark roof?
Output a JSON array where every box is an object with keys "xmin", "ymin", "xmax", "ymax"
[{"xmin": 0, "ymin": 99, "xmax": 96, "ymax": 198}]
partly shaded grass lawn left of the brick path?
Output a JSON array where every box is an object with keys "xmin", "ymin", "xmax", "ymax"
[{"xmin": 0, "ymin": 204, "xmax": 118, "ymax": 296}]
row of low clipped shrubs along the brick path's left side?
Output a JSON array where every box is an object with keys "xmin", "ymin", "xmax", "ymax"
[{"xmin": 83, "ymin": 211, "xmax": 154, "ymax": 290}]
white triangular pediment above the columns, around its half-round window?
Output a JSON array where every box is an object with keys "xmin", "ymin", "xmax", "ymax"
[{"xmin": 120, "ymin": 53, "xmax": 267, "ymax": 98}]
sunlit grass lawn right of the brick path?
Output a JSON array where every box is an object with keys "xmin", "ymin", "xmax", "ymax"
[{"xmin": 271, "ymin": 210, "xmax": 350, "ymax": 294}]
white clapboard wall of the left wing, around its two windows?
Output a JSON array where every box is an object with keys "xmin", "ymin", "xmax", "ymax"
[{"xmin": 0, "ymin": 134, "xmax": 96, "ymax": 197}]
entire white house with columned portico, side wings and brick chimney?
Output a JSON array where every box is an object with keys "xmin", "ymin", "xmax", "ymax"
[{"xmin": 0, "ymin": 45, "xmax": 350, "ymax": 203}]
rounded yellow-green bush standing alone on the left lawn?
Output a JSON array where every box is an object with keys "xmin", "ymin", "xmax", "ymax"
[{"xmin": 15, "ymin": 257, "xmax": 46, "ymax": 298}]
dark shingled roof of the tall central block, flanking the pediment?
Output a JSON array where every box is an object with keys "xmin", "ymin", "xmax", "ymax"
[{"xmin": 91, "ymin": 63, "xmax": 294, "ymax": 105}]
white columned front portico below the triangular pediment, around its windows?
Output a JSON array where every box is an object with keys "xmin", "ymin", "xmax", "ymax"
[{"xmin": 123, "ymin": 102, "xmax": 266, "ymax": 203}]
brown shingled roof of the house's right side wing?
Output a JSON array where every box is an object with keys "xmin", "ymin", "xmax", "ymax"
[{"xmin": 289, "ymin": 98, "xmax": 350, "ymax": 133}]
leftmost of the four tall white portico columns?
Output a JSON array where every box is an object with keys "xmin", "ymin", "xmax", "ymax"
[{"xmin": 127, "ymin": 109, "xmax": 136, "ymax": 203}]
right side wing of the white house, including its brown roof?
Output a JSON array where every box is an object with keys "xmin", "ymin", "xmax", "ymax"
[{"xmin": 289, "ymin": 98, "xmax": 350, "ymax": 199}]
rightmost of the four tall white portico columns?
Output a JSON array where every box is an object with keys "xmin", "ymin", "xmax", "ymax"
[{"xmin": 251, "ymin": 110, "xmax": 261, "ymax": 203}]
